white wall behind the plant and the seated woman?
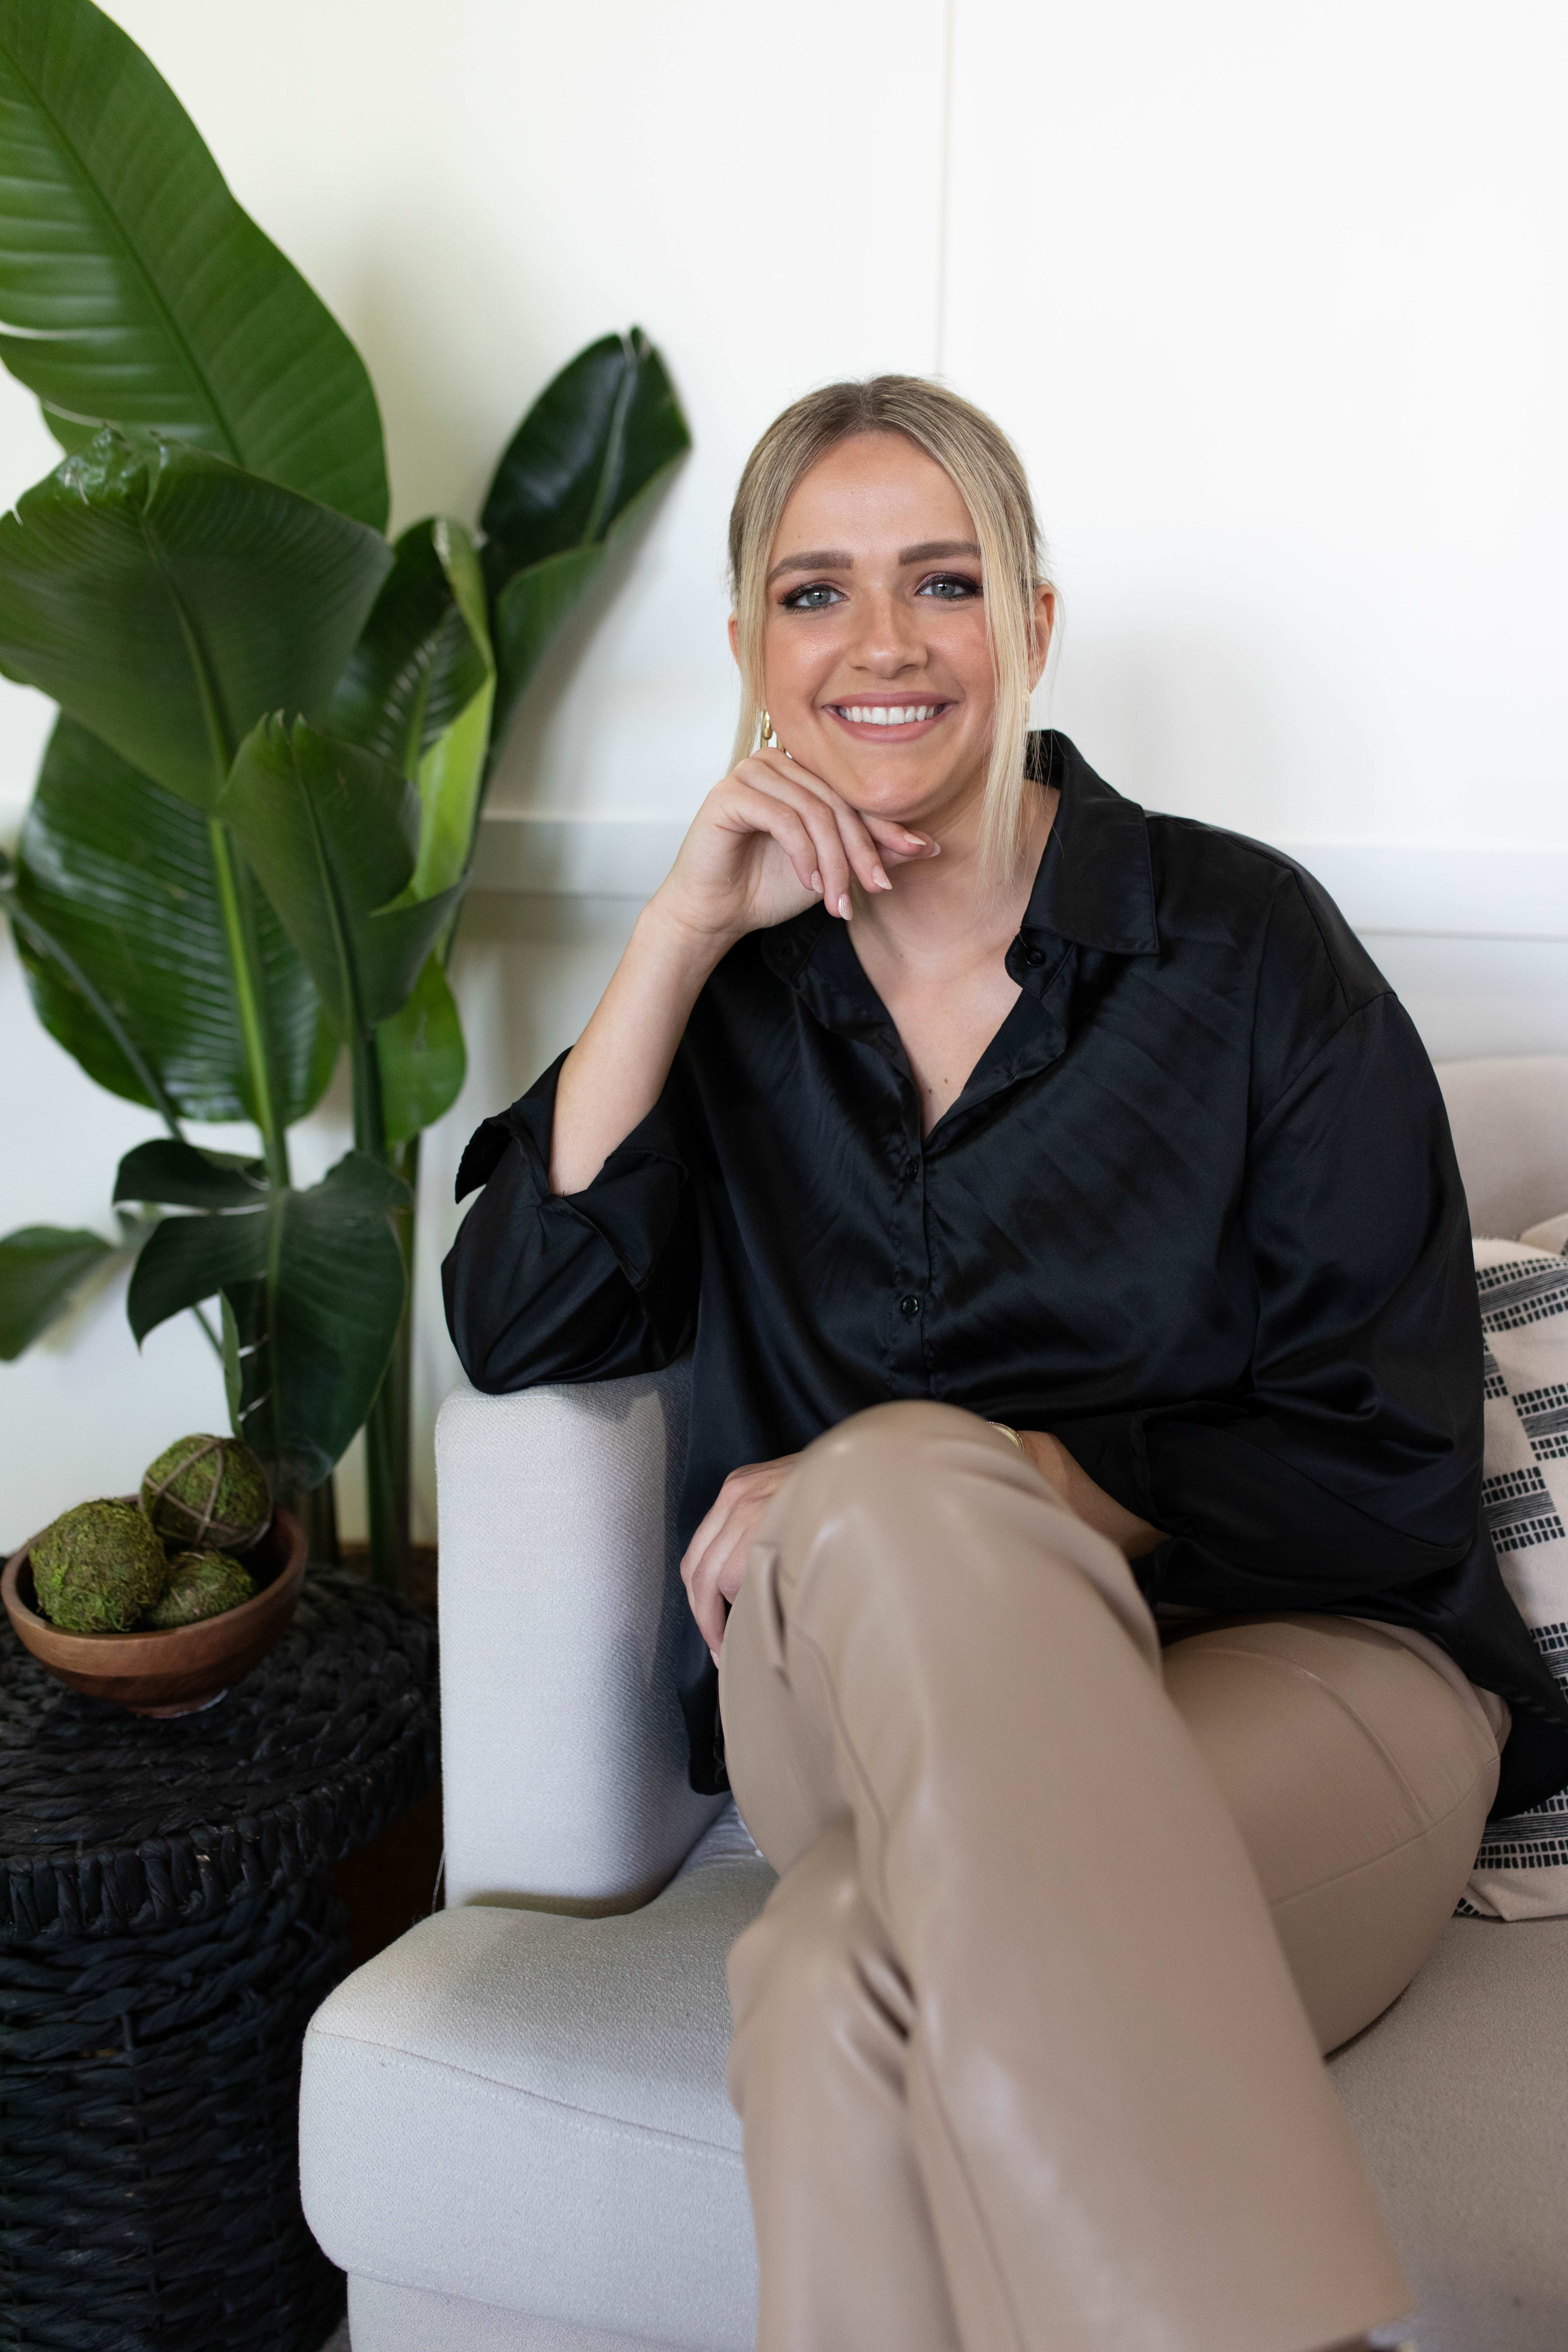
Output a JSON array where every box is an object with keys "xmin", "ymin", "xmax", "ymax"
[{"xmin": 0, "ymin": 0, "xmax": 1568, "ymax": 1538}]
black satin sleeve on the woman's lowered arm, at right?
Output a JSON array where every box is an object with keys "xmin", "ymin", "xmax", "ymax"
[{"xmin": 1060, "ymin": 995, "xmax": 1481, "ymax": 1609}]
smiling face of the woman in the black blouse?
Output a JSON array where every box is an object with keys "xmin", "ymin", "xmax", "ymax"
[{"xmin": 731, "ymin": 433, "xmax": 1051, "ymax": 823}]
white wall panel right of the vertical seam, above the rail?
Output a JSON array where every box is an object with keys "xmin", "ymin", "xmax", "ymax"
[{"xmin": 943, "ymin": 0, "xmax": 1568, "ymax": 842}]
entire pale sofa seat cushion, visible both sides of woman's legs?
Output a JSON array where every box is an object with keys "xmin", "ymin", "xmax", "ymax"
[{"xmin": 301, "ymin": 1816, "xmax": 1568, "ymax": 2352}]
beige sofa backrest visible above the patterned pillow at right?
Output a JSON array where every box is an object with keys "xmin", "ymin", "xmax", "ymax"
[{"xmin": 1437, "ymin": 1054, "xmax": 1568, "ymax": 1240}]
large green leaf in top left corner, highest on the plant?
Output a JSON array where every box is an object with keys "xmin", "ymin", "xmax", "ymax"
[{"xmin": 0, "ymin": 0, "xmax": 388, "ymax": 529}]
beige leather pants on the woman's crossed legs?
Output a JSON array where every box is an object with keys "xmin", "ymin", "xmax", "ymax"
[{"xmin": 719, "ymin": 1404, "xmax": 1497, "ymax": 2352}]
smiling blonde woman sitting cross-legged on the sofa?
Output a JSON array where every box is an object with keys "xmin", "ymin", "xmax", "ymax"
[{"xmin": 447, "ymin": 376, "xmax": 1568, "ymax": 2352}]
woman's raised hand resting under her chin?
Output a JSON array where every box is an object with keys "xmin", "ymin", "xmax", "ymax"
[{"xmin": 651, "ymin": 750, "xmax": 938, "ymax": 946}]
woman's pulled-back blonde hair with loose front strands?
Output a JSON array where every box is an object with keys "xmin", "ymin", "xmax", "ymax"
[{"xmin": 729, "ymin": 376, "xmax": 1049, "ymax": 882}]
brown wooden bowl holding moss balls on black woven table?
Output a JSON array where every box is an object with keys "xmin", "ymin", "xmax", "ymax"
[{"xmin": 0, "ymin": 1496, "xmax": 305, "ymax": 1715}]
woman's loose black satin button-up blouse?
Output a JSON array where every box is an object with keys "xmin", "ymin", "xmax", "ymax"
[{"xmin": 444, "ymin": 734, "xmax": 1568, "ymax": 1811}]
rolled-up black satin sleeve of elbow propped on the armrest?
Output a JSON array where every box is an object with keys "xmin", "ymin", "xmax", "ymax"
[{"xmin": 442, "ymin": 1054, "xmax": 698, "ymax": 1395}]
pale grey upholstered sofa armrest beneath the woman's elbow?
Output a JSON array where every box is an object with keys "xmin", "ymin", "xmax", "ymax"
[{"xmin": 435, "ymin": 1364, "xmax": 724, "ymax": 1915}]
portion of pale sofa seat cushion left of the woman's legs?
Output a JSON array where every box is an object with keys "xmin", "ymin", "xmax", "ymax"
[{"xmin": 301, "ymin": 1839, "xmax": 773, "ymax": 2352}]
